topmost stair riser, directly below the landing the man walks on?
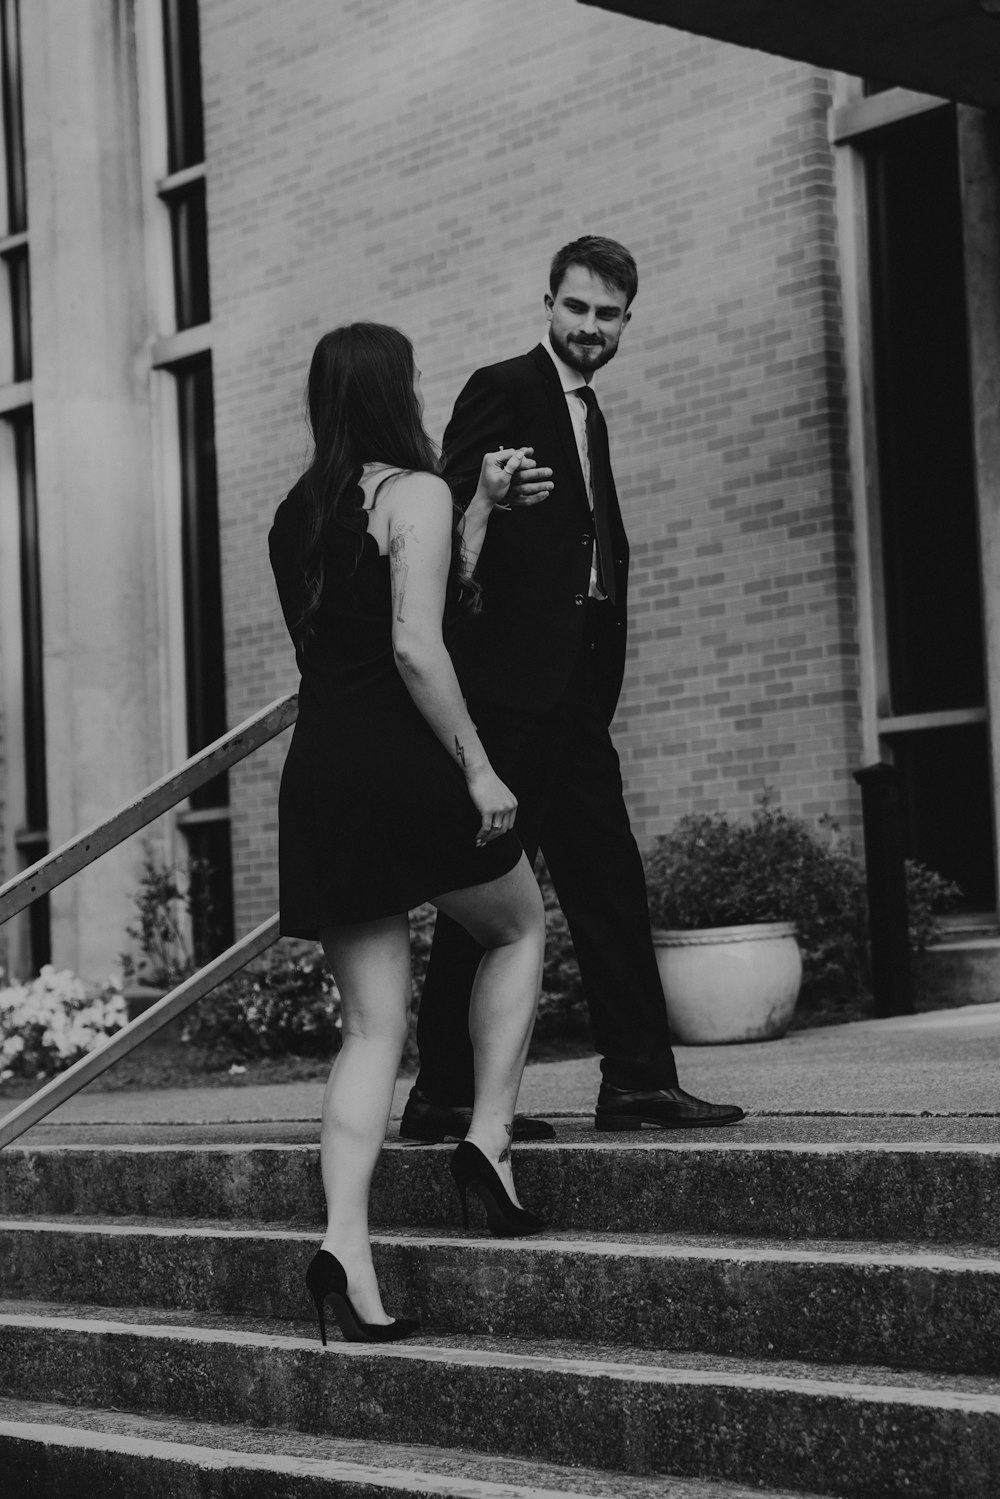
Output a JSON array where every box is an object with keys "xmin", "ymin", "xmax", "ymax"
[{"xmin": 0, "ymin": 1147, "xmax": 1000, "ymax": 1246}]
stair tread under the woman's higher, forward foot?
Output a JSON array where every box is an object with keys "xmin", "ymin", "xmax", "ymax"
[{"xmin": 0, "ymin": 1213, "xmax": 1000, "ymax": 1274}]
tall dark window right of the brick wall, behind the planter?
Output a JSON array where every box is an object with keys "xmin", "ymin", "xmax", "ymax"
[{"xmin": 843, "ymin": 88, "xmax": 997, "ymax": 913}]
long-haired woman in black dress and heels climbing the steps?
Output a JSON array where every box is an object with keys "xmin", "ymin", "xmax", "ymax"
[{"xmin": 270, "ymin": 322, "xmax": 544, "ymax": 1342}]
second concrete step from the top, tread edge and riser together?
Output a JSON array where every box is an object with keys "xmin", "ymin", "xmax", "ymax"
[{"xmin": 0, "ymin": 1217, "xmax": 1000, "ymax": 1375}]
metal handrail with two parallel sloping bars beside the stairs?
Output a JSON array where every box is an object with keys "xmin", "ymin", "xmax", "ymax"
[{"xmin": 0, "ymin": 693, "xmax": 298, "ymax": 1150}]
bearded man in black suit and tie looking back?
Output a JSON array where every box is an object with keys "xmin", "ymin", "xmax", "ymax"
[{"xmin": 400, "ymin": 235, "xmax": 744, "ymax": 1141}]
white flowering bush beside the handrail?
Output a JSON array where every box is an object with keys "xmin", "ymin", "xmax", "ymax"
[{"xmin": 0, "ymin": 964, "xmax": 129, "ymax": 1082}]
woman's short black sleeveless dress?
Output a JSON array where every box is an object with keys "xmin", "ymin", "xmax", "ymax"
[{"xmin": 268, "ymin": 470, "xmax": 520, "ymax": 940}]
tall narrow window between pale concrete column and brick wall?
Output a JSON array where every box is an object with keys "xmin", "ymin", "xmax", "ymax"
[{"xmin": 149, "ymin": 0, "xmax": 232, "ymax": 959}]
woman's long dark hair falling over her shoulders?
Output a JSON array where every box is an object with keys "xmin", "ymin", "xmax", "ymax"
[{"xmin": 295, "ymin": 322, "xmax": 480, "ymax": 645}]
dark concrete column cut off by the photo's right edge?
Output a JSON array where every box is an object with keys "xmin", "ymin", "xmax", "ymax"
[{"xmin": 958, "ymin": 105, "xmax": 1000, "ymax": 889}]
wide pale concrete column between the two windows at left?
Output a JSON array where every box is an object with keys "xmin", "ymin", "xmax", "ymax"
[{"xmin": 21, "ymin": 0, "xmax": 160, "ymax": 979}]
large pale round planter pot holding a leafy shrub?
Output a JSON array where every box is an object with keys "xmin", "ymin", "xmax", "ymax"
[{"xmin": 652, "ymin": 922, "xmax": 802, "ymax": 1046}]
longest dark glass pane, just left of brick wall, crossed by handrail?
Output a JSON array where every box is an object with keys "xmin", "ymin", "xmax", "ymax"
[{"xmin": 174, "ymin": 358, "xmax": 228, "ymax": 806}]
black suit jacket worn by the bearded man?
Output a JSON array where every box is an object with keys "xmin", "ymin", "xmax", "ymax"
[{"xmin": 444, "ymin": 343, "xmax": 628, "ymax": 721}]
